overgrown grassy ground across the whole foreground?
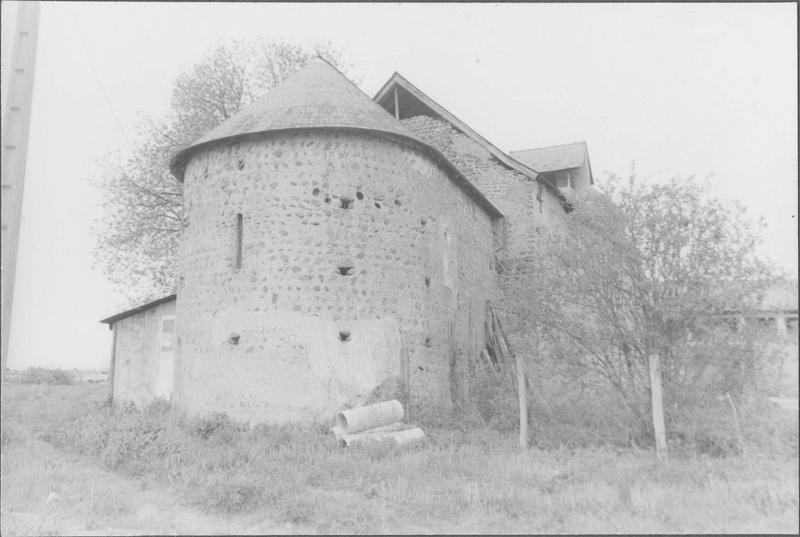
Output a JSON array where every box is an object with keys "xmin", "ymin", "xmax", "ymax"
[{"xmin": 0, "ymin": 384, "xmax": 798, "ymax": 535}]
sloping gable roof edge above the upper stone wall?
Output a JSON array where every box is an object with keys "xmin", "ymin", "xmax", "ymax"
[{"xmin": 373, "ymin": 71, "xmax": 566, "ymax": 201}]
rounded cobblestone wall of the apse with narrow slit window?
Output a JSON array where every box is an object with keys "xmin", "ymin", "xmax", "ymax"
[{"xmin": 173, "ymin": 130, "xmax": 500, "ymax": 422}]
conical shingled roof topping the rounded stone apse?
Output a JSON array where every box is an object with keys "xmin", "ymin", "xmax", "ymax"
[{"xmin": 170, "ymin": 59, "xmax": 427, "ymax": 180}]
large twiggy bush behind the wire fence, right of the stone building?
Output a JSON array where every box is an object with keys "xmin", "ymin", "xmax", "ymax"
[{"xmin": 502, "ymin": 172, "xmax": 775, "ymax": 442}]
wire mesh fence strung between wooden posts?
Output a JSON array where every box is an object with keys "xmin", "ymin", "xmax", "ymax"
[{"xmin": 450, "ymin": 312, "xmax": 798, "ymax": 456}]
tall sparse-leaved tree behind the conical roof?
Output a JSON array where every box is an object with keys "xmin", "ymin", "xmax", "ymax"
[{"xmin": 94, "ymin": 39, "xmax": 347, "ymax": 301}]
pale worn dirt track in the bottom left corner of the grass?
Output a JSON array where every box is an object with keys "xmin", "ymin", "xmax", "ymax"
[{"xmin": 0, "ymin": 440, "xmax": 306, "ymax": 537}]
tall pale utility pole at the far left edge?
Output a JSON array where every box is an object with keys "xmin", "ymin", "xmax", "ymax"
[{"xmin": 0, "ymin": 2, "xmax": 39, "ymax": 379}]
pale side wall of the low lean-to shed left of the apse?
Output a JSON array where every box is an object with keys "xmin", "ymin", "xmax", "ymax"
[{"xmin": 112, "ymin": 300, "xmax": 175, "ymax": 405}]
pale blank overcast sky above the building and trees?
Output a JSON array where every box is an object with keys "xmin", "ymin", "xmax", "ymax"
[{"xmin": 2, "ymin": 2, "xmax": 798, "ymax": 369}]
